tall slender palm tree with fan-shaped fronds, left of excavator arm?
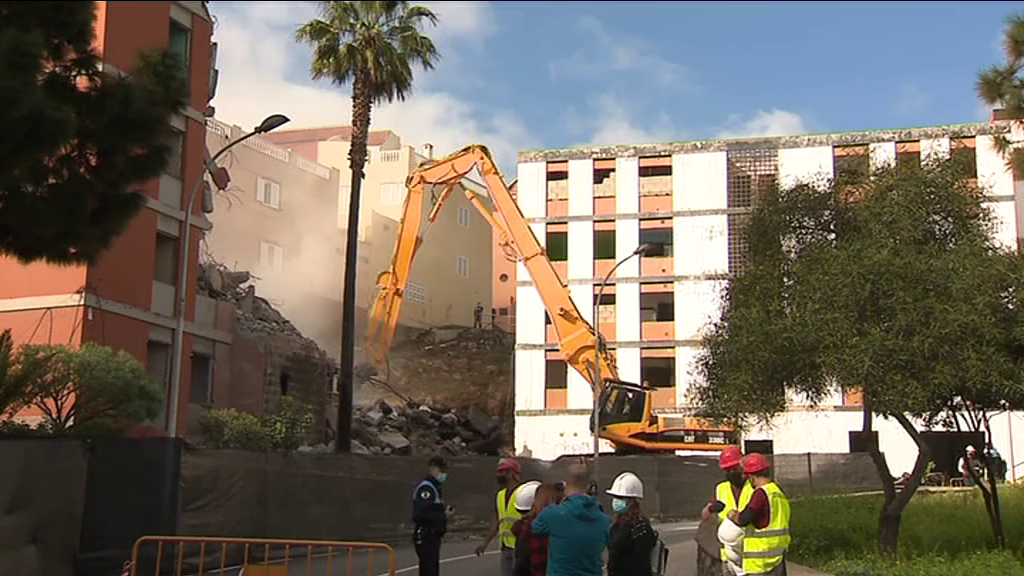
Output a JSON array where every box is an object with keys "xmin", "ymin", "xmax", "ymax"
[{"xmin": 295, "ymin": 1, "xmax": 440, "ymax": 452}]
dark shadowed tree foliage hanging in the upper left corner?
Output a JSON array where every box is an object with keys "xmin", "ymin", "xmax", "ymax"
[{"xmin": 0, "ymin": 1, "xmax": 187, "ymax": 264}]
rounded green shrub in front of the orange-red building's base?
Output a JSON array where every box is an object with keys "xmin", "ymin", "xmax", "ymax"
[{"xmin": 18, "ymin": 342, "xmax": 163, "ymax": 435}]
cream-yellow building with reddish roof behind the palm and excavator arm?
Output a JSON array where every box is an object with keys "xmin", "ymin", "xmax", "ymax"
[{"xmin": 266, "ymin": 126, "xmax": 493, "ymax": 338}]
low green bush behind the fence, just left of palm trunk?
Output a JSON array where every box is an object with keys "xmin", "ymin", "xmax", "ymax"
[{"xmin": 199, "ymin": 396, "xmax": 313, "ymax": 452}]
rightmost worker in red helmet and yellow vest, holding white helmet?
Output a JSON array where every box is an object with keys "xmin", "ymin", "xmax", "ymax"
[{"xmin": 728, "ymin": 453, "xmax": 790, "ymax": 576}]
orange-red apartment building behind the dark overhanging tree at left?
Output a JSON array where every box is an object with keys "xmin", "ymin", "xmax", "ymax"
[{"xmin": 0, "ymin": 1, "xmax": 218, "ymax": 435}]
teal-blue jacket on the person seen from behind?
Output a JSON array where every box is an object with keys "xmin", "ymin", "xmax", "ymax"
[{"xmin": 530, "ymin": 494, "xmax": 611, "ymax": 576}]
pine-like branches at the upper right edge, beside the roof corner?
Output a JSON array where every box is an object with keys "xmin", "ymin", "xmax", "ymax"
[{"xmin": 975, "ymin": 12, "xmax": 1024, "ymax": 174}]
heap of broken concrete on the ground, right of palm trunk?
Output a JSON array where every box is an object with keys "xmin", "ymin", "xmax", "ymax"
[{"xmin": 352, "ymin": 400, "xmax": 503, "ymax": 456}]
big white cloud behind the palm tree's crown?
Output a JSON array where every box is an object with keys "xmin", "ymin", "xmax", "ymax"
[{"xmin": 203, "ymin": 2, "xmax": 537, "ymax": 167}]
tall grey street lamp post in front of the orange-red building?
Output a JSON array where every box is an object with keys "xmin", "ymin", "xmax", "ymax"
[{"xmin": 167, "ymin": 114, "xmax": 290, "ymax": 438}]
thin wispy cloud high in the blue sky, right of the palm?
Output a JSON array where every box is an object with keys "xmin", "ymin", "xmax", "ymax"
[{"xmin": 548, "ymin": 15, "xmax": 691, "ymax": 89}]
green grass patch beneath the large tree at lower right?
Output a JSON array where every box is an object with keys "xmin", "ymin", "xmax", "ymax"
[{"xmin": 790, "ymin": 485, "xmax": 1024, "ymax": 576}]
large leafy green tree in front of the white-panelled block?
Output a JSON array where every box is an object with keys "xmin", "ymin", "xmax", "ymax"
[{"xmin": 694, "ymin": 155, "xmax": 1024, "ymax": 556}]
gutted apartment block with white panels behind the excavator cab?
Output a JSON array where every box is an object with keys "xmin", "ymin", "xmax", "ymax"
[{"xmin": 515, "ymin": 122, "xmax": 1024, "ymax": 467}]
